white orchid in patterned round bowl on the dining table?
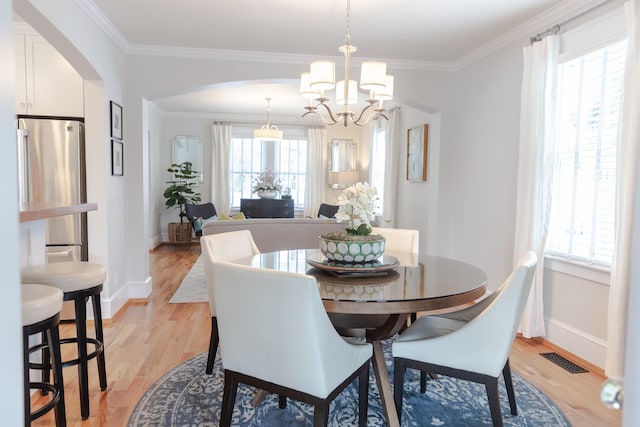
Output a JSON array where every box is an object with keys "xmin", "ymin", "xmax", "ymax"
[{"xmin": 320, "ymin": 182, "xmax": 385, "ymax": 262}]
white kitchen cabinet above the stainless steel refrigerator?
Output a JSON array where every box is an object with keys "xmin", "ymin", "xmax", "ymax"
[{"xmin": 14, "ymin": 34, "xmax": 84, "ymax": 117}]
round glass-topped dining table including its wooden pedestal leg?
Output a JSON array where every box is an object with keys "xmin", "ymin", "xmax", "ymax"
[{"xmin": 234, "ymin": 249, "xmax": 487, "ymax": 426}]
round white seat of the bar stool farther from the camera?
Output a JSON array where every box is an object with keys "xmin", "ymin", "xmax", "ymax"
[{"xmin": 22, "ymin": 261, "xmax": 107, "ymax": 293}]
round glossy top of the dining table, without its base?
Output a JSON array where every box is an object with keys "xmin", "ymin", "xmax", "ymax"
[{"xmin": 234, "ymin": 249, "xmax": 487, "ymax": 315}]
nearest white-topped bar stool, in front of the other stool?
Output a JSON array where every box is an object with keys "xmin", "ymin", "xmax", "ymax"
[{"xmin": 21, "ymin": 284, "xmax": 67, "ymax": 427}]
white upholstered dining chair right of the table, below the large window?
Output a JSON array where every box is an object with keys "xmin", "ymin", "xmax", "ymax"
[{"xmin": 392, "ymin": 252, "xmax": 537, "ymax": 426}]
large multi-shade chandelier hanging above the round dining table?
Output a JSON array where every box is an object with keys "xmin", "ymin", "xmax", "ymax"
[{"xmin": 300, "ymin": 0, "xmax": 393, "ymax": 126}]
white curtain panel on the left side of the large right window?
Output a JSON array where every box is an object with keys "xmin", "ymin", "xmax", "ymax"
[{"xmin": 513, "ymin": 35, "xmax": 559, "ymax": 338}]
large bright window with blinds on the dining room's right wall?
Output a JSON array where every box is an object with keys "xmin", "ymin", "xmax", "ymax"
[{"xmin": 546, "ymin": 41, "xmax": 626, "ymax": 266}]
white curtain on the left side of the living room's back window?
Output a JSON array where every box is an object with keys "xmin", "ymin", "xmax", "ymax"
[{"xmin": 211, "ymin": 123, "xmax": 231, "ymax": 215}]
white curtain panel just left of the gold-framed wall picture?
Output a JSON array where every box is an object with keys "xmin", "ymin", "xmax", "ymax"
[{"xmin": 370, "ymin": 107, "xmax": 404, "ymax": 227}]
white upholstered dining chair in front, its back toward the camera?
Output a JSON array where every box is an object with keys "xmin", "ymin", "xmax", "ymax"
[{"xmin": 212, "ymin": 263, "xmax": 372, "ymax": 426}]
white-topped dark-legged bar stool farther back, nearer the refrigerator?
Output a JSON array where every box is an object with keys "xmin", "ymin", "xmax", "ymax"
[{"xmin": 22, "ymin": 261, "xmax": 107, "ymax": 420}]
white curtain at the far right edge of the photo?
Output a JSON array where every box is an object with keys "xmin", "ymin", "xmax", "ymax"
[{"xmin": 605, "ymin": 0, "xmax": 640, "ymax": 377}]
